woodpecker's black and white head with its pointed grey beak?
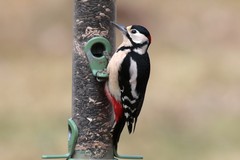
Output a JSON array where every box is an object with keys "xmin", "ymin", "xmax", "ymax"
[{"xmin": 112, "ymin": 22, "xmax": 151, "ymax": 47}]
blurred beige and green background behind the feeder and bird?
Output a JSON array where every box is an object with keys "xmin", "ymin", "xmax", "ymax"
[{"xmin": 0, "ymin": 0, "xmax": 240, "ymax": 160}]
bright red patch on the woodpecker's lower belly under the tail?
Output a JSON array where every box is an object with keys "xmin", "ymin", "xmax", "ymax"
[{"xmin": 104, "ymin": 84, "xmax": 123, "ymax": 123}]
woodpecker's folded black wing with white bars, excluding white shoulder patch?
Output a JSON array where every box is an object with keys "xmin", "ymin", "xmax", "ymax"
[{"xmin": 118, "ymin": 51, "xmax": 150, "ymax": 133}]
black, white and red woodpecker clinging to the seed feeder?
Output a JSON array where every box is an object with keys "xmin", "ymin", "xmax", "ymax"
[{"xmin": 105, "ymin": 22, "xmax": 151, "ymax": 153}]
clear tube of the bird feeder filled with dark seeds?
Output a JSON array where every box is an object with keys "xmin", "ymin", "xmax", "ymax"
[{"xmin": 72, "ymin": 0, "xmax": 115, "ymax": 159}]
